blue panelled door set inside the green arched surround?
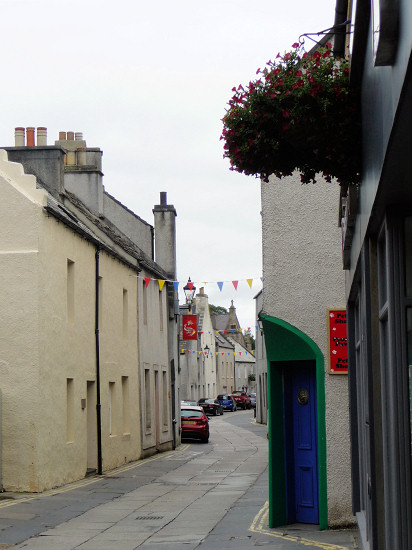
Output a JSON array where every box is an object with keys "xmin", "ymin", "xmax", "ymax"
[{"xmin": 283, "ymin": 361, "xmax": 319, "ymax": 524}]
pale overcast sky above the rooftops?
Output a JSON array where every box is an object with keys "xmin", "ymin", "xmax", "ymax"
[{"xmin": 0, "ymin": 0, "xmax": 334, "ymax": 328}]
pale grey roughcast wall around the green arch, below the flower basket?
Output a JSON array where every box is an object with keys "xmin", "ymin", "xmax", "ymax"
[{"xmin": 261, "ymin": 174, "xmax": 353, "ymax": 525}]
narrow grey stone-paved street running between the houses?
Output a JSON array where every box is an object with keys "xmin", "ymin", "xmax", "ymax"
[{"xmin": 0, "ymin": 411, "xmax": 357, "ymax": 550}]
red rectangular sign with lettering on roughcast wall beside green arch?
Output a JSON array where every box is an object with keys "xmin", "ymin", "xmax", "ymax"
[{"xmin": 328, "ymin": 309, "xmax": 348, "ymax": 374}]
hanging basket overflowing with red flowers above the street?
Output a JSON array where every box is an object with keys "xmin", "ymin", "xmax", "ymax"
[{"xmin": 221, "ymin": 43, "xmax": 361, "ymax": 184}]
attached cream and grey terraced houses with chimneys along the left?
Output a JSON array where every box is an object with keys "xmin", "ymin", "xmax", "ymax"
[{"xmin": 0, "ymin": 128, "xmax": 178, "ymax": 492}]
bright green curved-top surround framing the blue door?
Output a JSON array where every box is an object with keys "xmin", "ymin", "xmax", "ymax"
[{"xmin": 260, "ymin": 314, "xmax": 328, "ymax": 529}]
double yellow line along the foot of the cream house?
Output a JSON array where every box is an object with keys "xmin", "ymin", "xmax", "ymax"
[{"xmin": 0, "ymin": 445, "xmax": 189, "ymax": 509}]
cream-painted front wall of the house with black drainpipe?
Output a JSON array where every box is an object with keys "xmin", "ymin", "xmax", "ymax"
[{"xmin": 0, "ymin": 152, "xmax": 141, "ymax": 491}]
